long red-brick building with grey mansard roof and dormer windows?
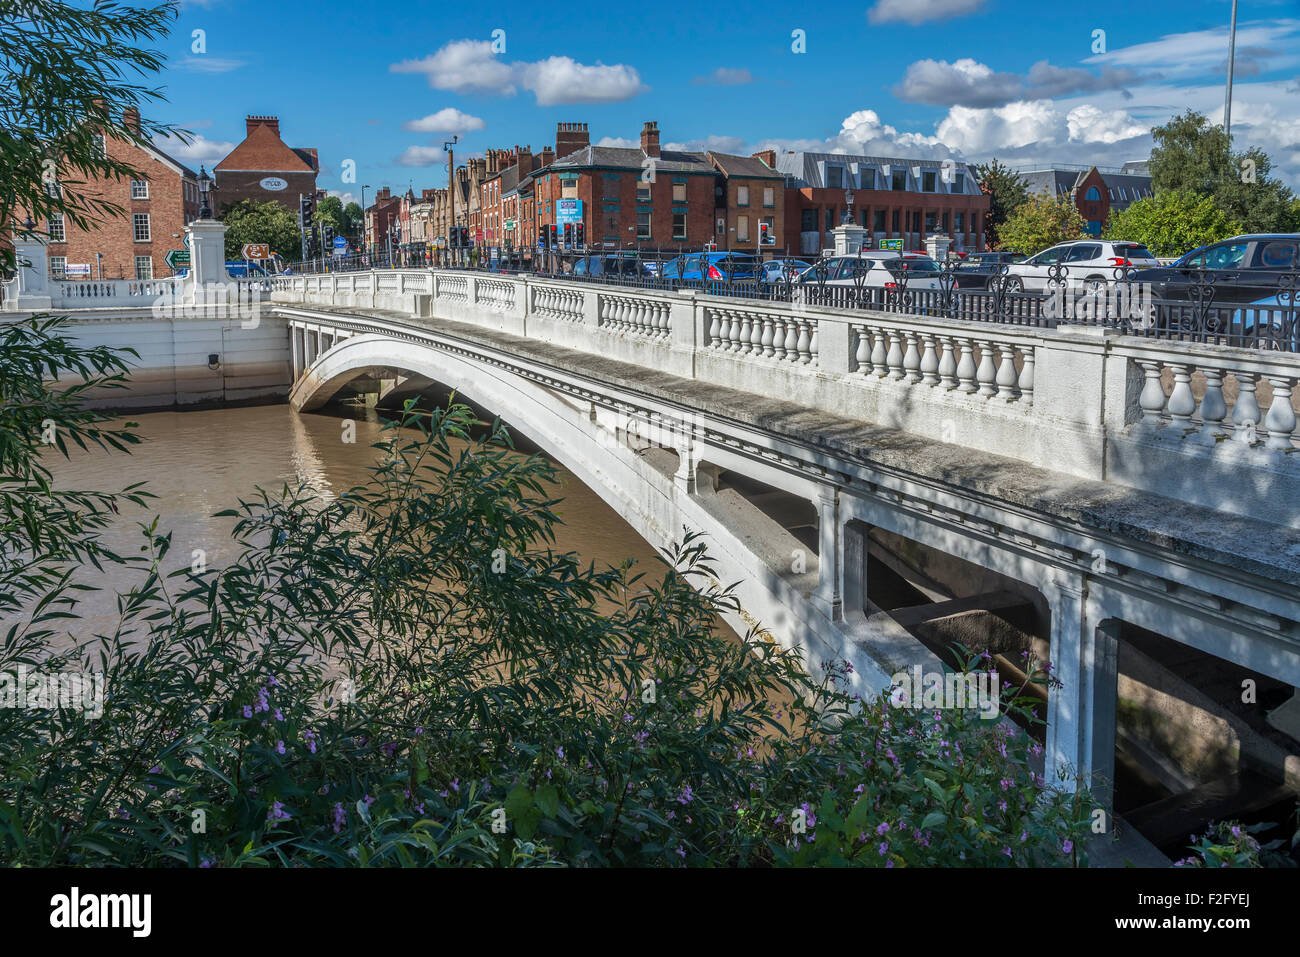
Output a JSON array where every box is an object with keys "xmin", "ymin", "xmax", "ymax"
[{"xmin": 776, "ymin": 151, "xmax": 989, "ymax": 256}]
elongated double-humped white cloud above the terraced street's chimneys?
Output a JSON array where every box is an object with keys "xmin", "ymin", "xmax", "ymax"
[{"xmin": 389, "ymin": 40, "xmax": 649, "ymax": 107}]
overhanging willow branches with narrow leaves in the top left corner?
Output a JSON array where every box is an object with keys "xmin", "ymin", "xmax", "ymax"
[{"xmin": 0, "ymin": 0, "xmax": 189, "ymax": 272}]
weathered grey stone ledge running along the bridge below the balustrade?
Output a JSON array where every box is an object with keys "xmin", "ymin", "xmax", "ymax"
[{"xmin": 274, "ymin": 304, "xmax": 1300, "ymax": 586}]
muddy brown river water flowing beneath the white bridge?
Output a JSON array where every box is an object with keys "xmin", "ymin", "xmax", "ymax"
[{"xmin": 35, "ymin": 406, "xmax": 660, "ymax": 650}]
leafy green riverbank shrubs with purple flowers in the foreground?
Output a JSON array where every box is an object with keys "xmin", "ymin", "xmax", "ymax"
[{"xmin": 0, "ymin": 324, "xmax": 1091, "ymax": 867}]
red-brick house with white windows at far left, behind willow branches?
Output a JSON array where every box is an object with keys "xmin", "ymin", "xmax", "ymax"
[{"xmin": 18, "ymin": 108, "xmax": 199, "ymax": 280}]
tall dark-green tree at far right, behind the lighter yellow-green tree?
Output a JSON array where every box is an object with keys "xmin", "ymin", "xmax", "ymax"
[{"xmin": 1151, "ymin": 109, "xmax": 1296, "ymax": 233}]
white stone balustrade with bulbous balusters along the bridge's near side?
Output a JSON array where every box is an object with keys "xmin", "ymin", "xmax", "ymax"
[{"xmin": 272, "ymin": 269, "xmax": 1300, "ymax": 521}]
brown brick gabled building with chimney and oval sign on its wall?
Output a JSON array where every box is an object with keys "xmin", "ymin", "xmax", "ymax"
[{"xmin": 212, "ymin": 116, "xmax": 320, "ymax": 218}]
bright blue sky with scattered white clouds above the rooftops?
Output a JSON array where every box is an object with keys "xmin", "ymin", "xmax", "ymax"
[{"xmin": 153, "ymin": 0, "xmax": 1300, "ymax": 198}]
